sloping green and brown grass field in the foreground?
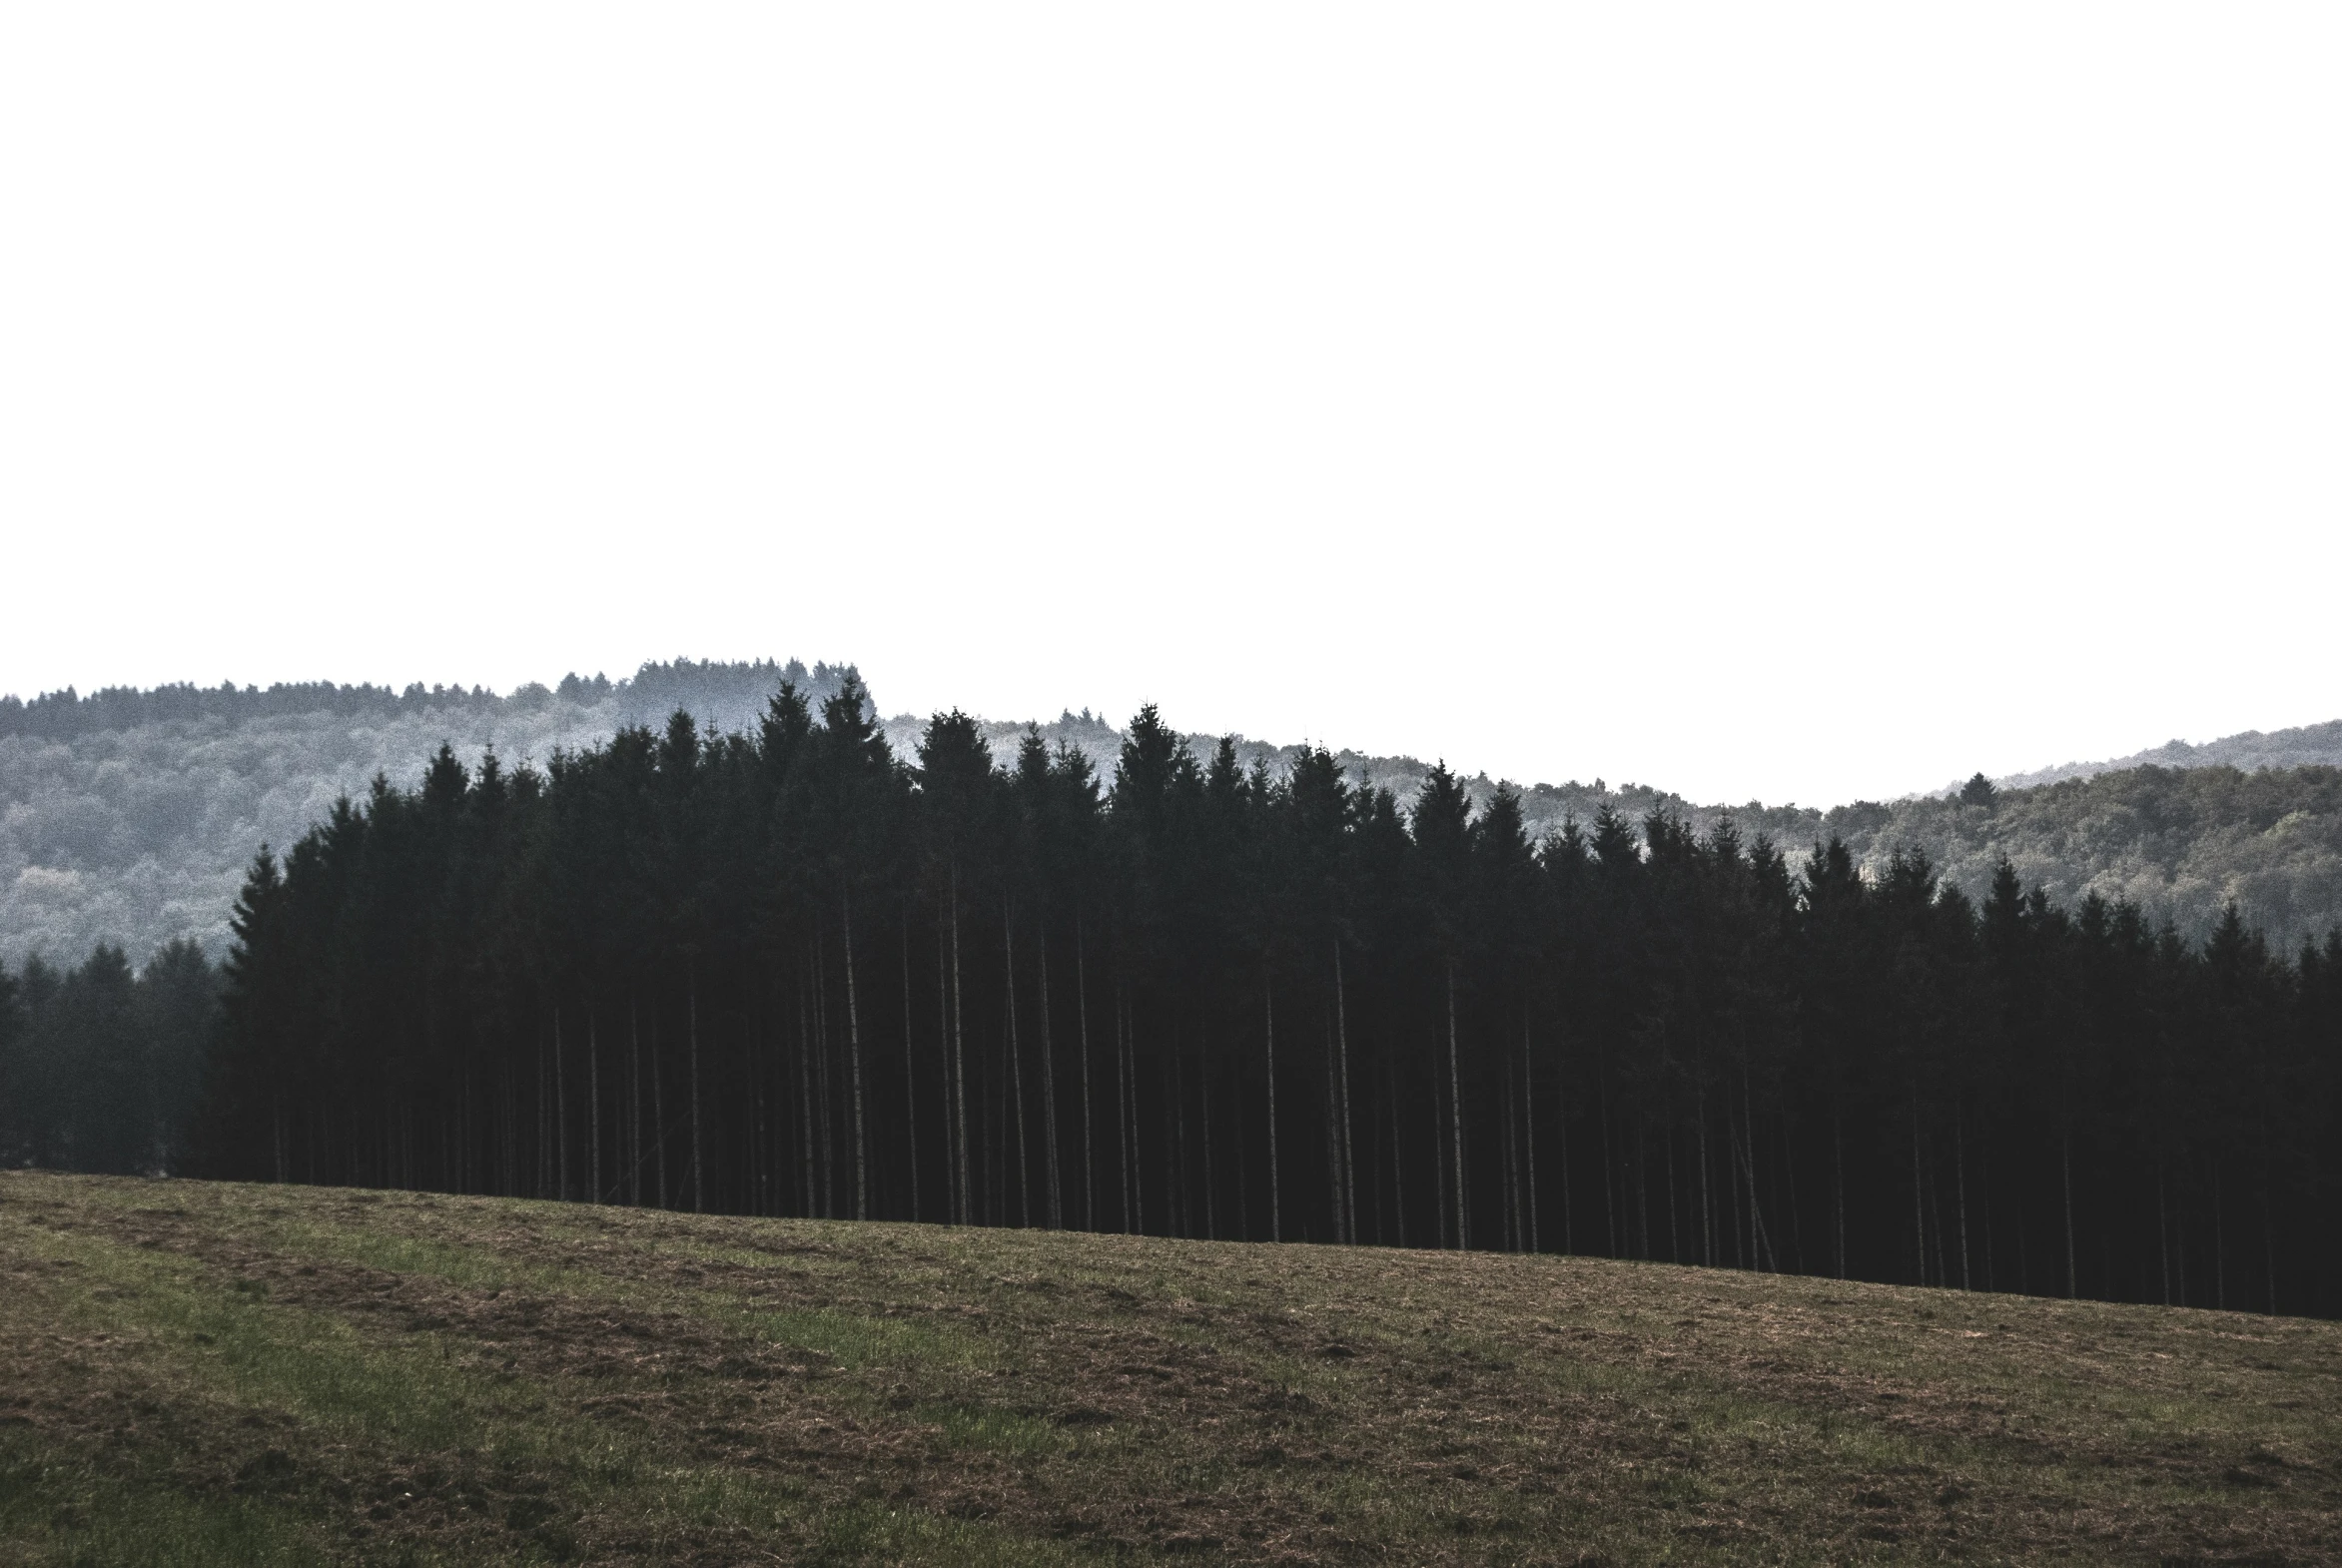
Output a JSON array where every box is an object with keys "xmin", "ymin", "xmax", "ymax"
[{"xmin": 0, "ymin": 1173, "xmax": 2342, "ymax": 1566}]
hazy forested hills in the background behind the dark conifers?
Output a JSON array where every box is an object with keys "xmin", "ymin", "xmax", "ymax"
[{"xmin": 0, "ymin": 660, "xmax": 2342, "ymax": 964}]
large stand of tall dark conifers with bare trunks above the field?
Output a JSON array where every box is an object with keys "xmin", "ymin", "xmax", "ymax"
[{"xmin": 206, "ymin": 681, "xmax": 2342, "ymax": 1313}]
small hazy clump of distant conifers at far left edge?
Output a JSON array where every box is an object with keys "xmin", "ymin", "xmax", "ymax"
[{"xmin": 0, "ymin": 941, "xmax": 220, "ymax": 1175}]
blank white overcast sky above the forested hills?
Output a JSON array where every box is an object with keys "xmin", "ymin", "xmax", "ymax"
[{"xmin": 0, "ymin": 0, "xmax": 2342, "ymax": 805}]
